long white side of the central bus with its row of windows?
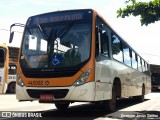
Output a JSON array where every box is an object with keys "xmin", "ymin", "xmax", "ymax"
[{"xmin": 95, "ymin": 12, "xmax": 150, "ymax": 101}]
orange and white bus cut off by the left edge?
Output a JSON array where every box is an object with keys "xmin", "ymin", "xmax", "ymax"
[{"xmin": 0, "ymin": 44, "xmax": 9, "ymax": 94}]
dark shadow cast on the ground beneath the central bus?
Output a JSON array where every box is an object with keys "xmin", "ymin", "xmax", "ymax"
[{"xmin": 34, "ymin": 99, "xmax": 160, "ymax": 120}]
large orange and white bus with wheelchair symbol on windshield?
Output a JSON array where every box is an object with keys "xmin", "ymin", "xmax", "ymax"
[{"xmin": 10, "ymin": 9, "xmax": 151, "ymax": 111}]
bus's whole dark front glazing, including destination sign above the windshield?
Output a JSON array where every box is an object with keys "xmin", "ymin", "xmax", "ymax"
[{"xmin": 20, "ymin": 10, "xmax": 92, "ymax": 78}]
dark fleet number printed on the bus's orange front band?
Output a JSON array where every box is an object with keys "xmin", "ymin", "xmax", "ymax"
[{"xmin": 28, "ymin": 80, "xmax": 49, "ymax": 86}]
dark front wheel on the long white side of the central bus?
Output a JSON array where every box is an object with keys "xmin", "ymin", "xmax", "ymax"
[{"xmin": 103, "ymin": 85, "xmax": 117, "ymax": 112}]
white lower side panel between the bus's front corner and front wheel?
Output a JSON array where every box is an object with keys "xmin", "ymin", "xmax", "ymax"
[{"xmin": 95, "ymin": 59, "xmax": 113, "ymax": 101}]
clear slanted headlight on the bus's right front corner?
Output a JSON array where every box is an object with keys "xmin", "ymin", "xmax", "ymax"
[{"xmin": 73, "ymin": 69, "xmax": 91, "ymax": 87}]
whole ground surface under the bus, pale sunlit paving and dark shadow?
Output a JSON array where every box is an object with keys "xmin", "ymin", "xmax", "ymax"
[{"xmin": 0, "ymin": 91, "xmax": 160, "ymax": 120}]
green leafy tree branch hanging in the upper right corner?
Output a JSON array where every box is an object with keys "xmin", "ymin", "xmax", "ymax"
[{"xmin": 117, "ymin": 0, "xmax": 160, "ymax": 25}]
